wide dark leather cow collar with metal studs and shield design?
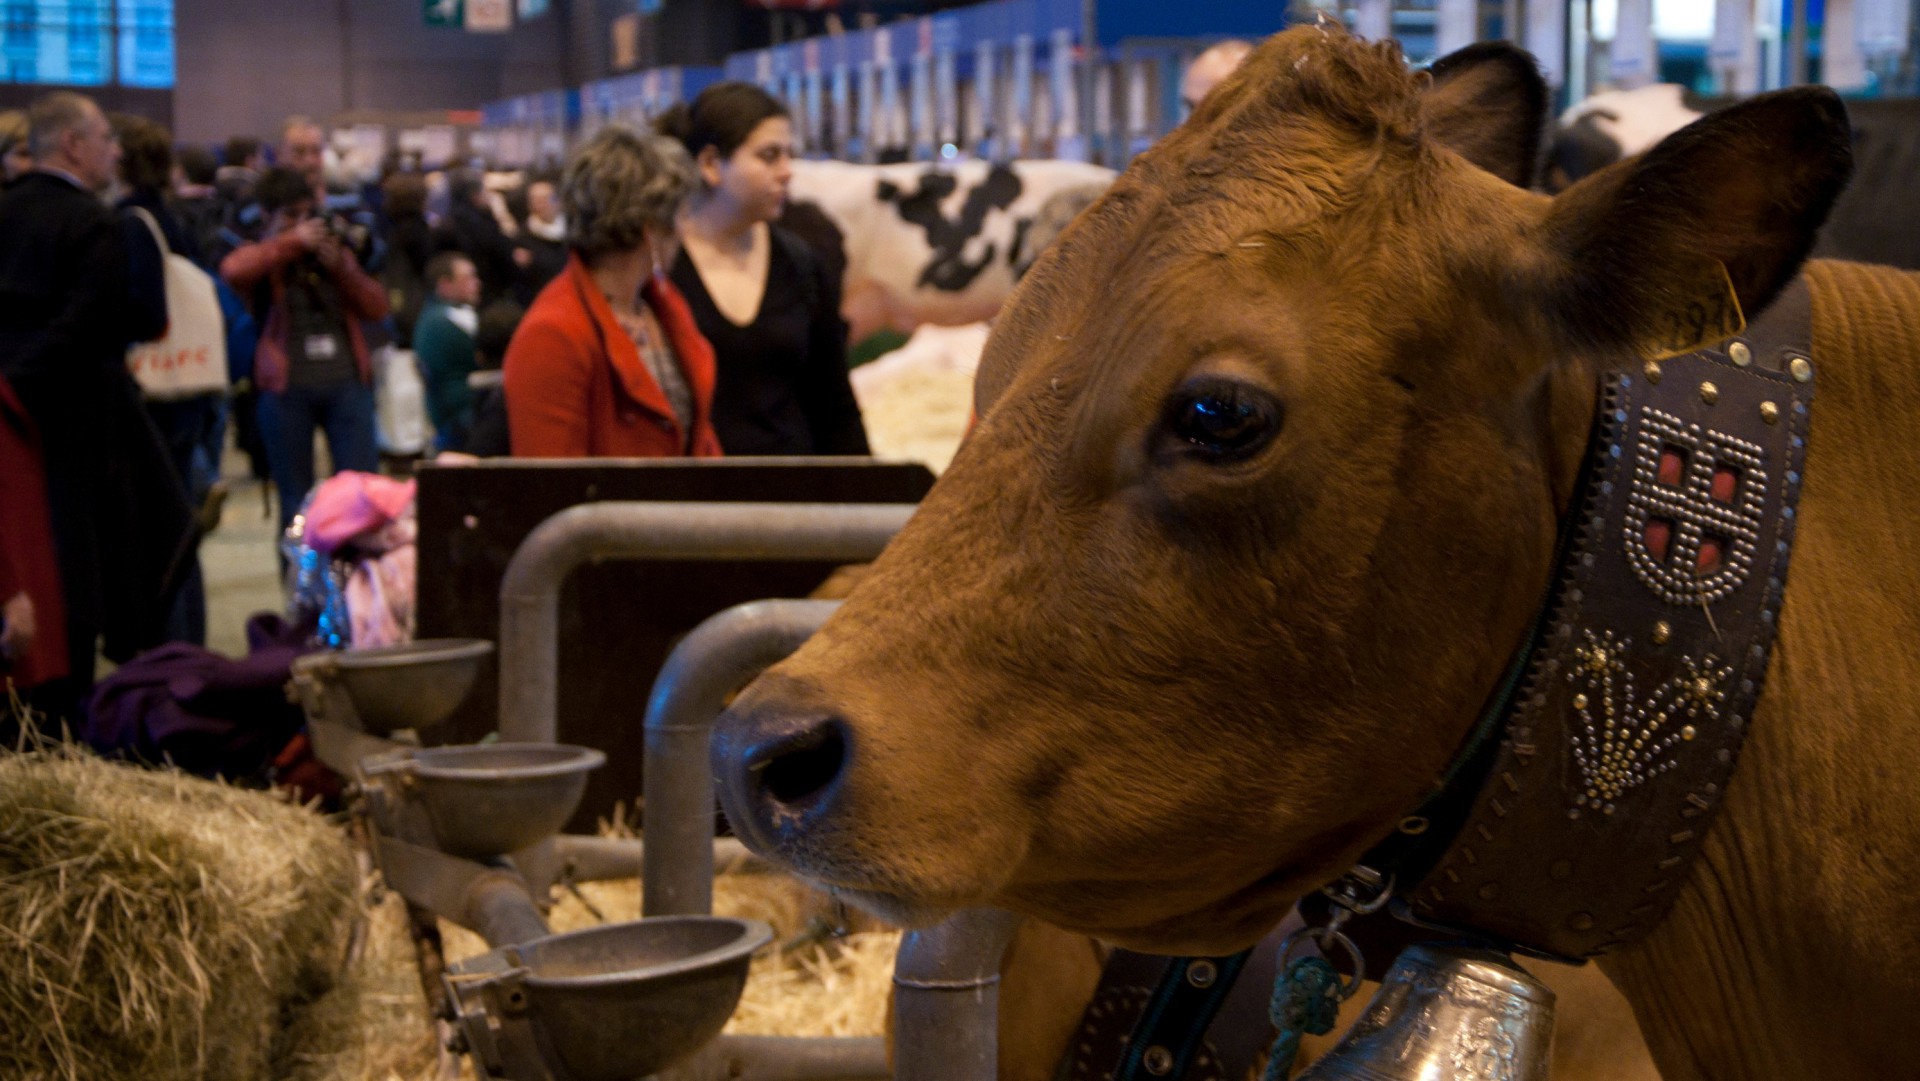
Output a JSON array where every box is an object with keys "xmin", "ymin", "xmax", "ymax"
[{"xmin": 1365, "ymin": 280, "xmax": 1814, "ymax": 960}]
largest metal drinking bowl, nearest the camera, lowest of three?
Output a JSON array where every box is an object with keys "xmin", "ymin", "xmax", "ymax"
[{"xmin": 445, "ymin": 916, "xmax": 774, "ymax": 1081}]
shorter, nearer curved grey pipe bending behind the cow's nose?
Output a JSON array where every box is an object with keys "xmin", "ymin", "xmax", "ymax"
[{"xmin": 639, "ymin": 601, "xmax": 839, "ymax": 916}]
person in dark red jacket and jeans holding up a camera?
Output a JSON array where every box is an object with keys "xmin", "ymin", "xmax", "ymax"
[{"xmin": 221, "ymin": 169, "xmax": 388, "ymax": 528}]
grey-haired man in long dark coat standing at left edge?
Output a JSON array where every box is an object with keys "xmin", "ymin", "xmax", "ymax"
[{"xmin": 0, "ymin": 92, "xmax": 188, "ymax": 720}]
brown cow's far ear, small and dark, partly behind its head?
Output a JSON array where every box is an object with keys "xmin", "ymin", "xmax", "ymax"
[{"xmin": 1421, "ymin": 42, "xmax": 1548, "ymax": 188}]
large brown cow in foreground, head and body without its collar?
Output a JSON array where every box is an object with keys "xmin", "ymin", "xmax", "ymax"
[{"xmin": 714, "ymin": 29, "xmax": 1920, "ymax": 1081}]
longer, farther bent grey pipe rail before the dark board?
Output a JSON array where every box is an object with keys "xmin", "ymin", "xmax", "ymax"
[{"xmin": 499, "ymin": 503, "xmax": 914, "ymax": 743}]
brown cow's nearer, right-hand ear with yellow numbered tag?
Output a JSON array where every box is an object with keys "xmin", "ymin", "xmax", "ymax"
[{"xmin": 1515, "ymin": 86, "xmax": 1853, "ymax": 355}]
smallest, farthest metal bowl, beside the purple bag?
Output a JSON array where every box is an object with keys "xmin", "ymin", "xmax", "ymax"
[{"xmin": 323, "ymin": 637, "xmax": 493, "ymax": 735}]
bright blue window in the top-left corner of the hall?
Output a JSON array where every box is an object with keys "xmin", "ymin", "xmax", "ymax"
[{"xmin": 0, "ymin": 0, "xmax": 173, "ymax": 88}]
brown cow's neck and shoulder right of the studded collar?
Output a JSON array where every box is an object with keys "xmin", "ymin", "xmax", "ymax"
[{"xmin": 1607, "ymin": 261, "xmax": 1920, "ymax": 1077}]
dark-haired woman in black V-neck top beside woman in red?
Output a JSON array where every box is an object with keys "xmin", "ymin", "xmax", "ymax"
[{"xmin": 659, "ymin": 83, "xmax": 868, "ymax": 455}]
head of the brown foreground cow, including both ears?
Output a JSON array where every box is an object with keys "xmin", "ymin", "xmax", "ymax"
[{"xmin": 714, "ymin": 29, "xmax": 1847, "ymax": 950}]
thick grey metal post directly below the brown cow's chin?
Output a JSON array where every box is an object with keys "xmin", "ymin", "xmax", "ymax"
[{"xmin": 893, "ymin": 908, "xmax": 1020, "ymax": 1081}]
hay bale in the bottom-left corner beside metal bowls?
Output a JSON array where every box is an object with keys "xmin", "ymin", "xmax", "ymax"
[{"xmin": 0, "ymin": 749, "xmax": 359, "ymax": 1081}]
